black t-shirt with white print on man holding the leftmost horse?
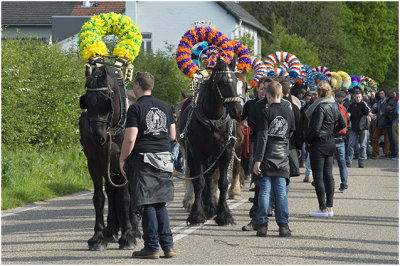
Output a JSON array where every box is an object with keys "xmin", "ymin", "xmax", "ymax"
[{"xmin": 125, "ymin": 95, "xmax": 175, "ymax": 154}]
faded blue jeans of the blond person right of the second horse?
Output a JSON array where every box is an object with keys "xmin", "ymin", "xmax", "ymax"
[{"xmin": 257, "ymin": 176, "xmax": 289, "ymax": 224}]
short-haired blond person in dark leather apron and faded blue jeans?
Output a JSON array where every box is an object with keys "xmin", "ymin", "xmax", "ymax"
[{"xmin": 253, "ymin": 81, "xmax": 295, "ymax": 237}]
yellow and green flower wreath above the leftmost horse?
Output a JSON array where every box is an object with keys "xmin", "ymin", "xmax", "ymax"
[{"xmin": 78, "ymin": 12, "xmax": 142, "ymax": 61}]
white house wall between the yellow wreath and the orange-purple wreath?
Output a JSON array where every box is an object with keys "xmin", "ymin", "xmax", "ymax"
[{"xmin": 126, "ymin": 1, "xmax": 237, "ymax": 50}]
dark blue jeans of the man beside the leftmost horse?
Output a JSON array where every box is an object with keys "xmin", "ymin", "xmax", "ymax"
[{"xmin": 142, "ymin": 202, "xmax": 174, "ymax": 252}]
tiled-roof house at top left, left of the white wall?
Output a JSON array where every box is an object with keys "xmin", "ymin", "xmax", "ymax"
[{"xmin": 1, "ymin": 1, "xmax": 125, "ymax": 42}]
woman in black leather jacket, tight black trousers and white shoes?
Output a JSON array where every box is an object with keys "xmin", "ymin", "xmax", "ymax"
[{"xmin": 305, "ymin": 81, "xmax": 346, "ymax": 217}]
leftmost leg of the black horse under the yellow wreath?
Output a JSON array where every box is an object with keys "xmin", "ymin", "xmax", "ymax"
[{"xmin": 88, "ymin": 172, "xmax": 107, "ymax": 250}]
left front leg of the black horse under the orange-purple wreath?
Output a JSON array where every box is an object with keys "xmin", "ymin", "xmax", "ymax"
[{"xmin": 186, "ymin": 153, "xmax": 206, "ymax": 225}]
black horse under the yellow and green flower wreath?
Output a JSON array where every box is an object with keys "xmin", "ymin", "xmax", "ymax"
[{"xmin": 79, "ymin": 59, "xmax": 141, "ymax": 250}]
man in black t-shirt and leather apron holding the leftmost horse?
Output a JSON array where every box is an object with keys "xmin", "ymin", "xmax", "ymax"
[{"xmin": 120, "ymin": 72, "xmax": 176, "ymax": 259}]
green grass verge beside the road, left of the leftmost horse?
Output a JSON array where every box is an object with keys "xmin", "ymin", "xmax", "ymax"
[{"xmin": 1, "ymin": 146, "xmax": 93, "ymax": 210}]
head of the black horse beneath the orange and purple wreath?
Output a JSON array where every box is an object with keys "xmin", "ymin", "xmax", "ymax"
[{"xmin": 210, "ymin": 57, "xmax": 243, "ymax": 119}]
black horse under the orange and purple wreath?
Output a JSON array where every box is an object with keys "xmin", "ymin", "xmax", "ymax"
[{"xmin": 179, "ymin": 58, "xmax": 242, "ymax": 225}]
